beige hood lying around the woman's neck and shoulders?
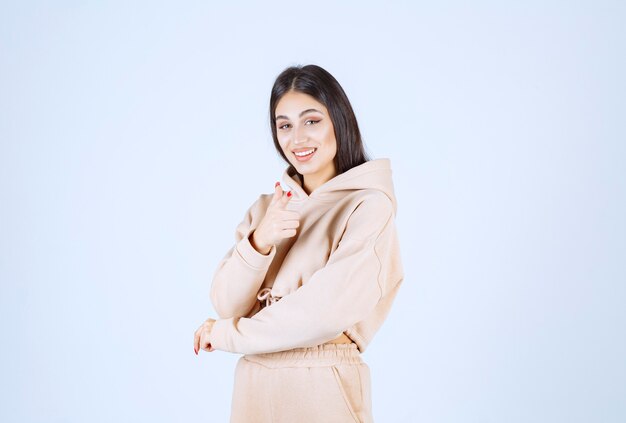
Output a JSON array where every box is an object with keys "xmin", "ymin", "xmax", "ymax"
[{"xmin": 282, "ymin": 158, "xmax": 397, "ymax": 214}]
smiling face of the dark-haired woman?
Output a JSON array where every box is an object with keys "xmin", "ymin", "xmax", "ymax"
[{"xmin": 275, "ymin": 91, "xmax": 337, "ymax": 185}]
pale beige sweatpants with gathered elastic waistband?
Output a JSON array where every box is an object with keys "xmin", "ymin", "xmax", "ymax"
[{"xmin": 230, "ymin": 343, "xmax": 373, "ymax": 423}]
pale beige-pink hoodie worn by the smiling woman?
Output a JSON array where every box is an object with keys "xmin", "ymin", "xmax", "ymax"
[{"xmin": 209, "ymin": 158, "xmax": 404, "ymax": 354}]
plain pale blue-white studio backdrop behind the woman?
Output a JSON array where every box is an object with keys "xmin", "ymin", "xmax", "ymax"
[{"xmin": 0, "ymin": 1, "xmax": 626, "ymax": 423}]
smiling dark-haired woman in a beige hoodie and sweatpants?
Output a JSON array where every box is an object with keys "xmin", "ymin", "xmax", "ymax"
[{"xmin": 194, "ymin": 65, "xmax": 403, "ymax": 423}]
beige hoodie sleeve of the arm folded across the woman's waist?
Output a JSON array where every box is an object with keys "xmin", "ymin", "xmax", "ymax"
[{"xmin": 210, "ymin": 195, "xmax": 394, "ymax": 354}]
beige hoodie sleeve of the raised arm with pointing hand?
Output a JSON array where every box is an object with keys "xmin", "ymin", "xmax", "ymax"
[{"xmin": 210, "ymin": 197, "xmax": 276, "ymax": 319}]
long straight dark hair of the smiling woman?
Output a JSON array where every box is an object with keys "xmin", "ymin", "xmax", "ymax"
[{"xmin": 270, "ymin": 65, "xmax": 370, "ymax": 182}]
